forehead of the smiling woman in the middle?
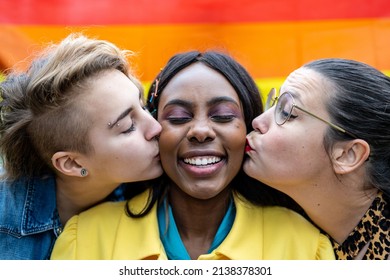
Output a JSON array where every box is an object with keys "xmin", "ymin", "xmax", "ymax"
[{"xmin": 160, "ymin": 63, "xmax": 239, "ymax": 102}]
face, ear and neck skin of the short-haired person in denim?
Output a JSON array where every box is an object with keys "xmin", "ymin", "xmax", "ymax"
[{"xmin": 55, "ymin": 70, "xmax": 162, "ymax": 225}]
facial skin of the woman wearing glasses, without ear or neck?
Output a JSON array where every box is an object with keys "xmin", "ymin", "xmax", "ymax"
[{"xmin": 244, "ymin": 68, "xmax": 330, "ymax": 191}]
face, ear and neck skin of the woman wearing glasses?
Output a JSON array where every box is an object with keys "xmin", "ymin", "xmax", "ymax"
[{"xmin": 244, "ymin": 68, "xmax": 376, "ymax": 254}]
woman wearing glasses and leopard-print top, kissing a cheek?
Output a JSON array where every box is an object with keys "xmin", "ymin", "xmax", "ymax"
[{"xmin": 244, "ymin": 59, "xmax": 390, "ymax": 259}]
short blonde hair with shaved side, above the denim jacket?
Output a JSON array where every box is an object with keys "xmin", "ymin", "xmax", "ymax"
[{"xmin": 0, "ymin": 34, "xmax": 139, "ymax": 179}]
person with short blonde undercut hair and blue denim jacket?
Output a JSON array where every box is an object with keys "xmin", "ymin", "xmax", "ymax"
[{"xmin": 0, "ymin": 35, "xmax": 162, "ymax": 259}]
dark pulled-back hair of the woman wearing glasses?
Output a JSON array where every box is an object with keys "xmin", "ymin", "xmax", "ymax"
[{"xmin": 304, "ymin": 58, "xmax": 390, "ymax": 196}]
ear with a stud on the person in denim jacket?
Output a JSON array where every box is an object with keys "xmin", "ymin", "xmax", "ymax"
[{"xmin": 51, "ymin": 152, "xmax": 88, "ymax": 177}]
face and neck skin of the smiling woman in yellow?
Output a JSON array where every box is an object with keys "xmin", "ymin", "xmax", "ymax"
[{"xmin": 158, "ymin": 63, "xmax": 246, "ymax": 259}]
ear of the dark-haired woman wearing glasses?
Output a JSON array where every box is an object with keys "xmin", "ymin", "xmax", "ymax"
[{"xmin": 332, "ymin": 139, "xmax": 370, "ymax": 174}]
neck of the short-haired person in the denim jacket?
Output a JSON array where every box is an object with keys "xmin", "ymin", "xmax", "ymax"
[{"xmin": 56, "ymin": 176, "xmax": 116, "ymax": 225}]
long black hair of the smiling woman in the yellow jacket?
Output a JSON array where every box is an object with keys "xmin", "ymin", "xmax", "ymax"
[{"xmin": 127, "ymin": 51, "xmax": 300, "ymax": 217}]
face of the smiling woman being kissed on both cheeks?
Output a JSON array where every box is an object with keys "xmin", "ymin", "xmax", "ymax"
[{"xmin": 158, "ymin": 63, "xmax": 246, "ymax": 199}]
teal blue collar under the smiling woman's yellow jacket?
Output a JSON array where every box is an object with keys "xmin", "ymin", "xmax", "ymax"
[{"xmin": 157, "ymin": 199, "xmax": 236, "ymax": 260}]
